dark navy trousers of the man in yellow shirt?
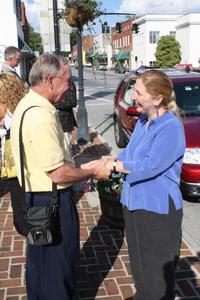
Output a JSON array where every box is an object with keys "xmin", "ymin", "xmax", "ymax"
[{"xmin": 26, "ymin": 188, "xmax": 79, "ymax": 300}]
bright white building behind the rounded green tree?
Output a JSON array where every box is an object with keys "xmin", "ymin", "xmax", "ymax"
[{"xmin": 131, "ymin": 13, "xmax": 200, "ymax": 69}]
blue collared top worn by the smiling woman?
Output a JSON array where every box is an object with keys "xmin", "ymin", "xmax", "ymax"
[{"xmin": 117, "ymin": 112, "xmax": 186, "ymax": 214}]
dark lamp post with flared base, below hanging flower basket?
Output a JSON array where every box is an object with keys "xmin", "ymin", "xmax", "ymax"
[{"xmin": 76, "ymin": 30, "xmax": 90, "ymax": 144}]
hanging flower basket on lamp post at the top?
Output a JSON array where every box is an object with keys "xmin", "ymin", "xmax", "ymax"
[{"xmin": 63, "ymin": 0, "xmax": 102, "ymax": 28}]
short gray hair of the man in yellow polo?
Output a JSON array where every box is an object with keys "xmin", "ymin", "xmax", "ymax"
[{"xmin": 29, "ymin": 53, "xmax": 63, "ymax": 86}]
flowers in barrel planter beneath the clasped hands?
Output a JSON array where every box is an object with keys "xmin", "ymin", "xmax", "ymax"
[{"xmin": 88, "ymin": 173, "xmax": 124, "ymax": 197}]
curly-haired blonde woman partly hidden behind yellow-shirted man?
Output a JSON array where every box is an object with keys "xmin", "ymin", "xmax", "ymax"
[{"xmin": 0, "ymin": 72, "xmax": 27, "ymax": 234}]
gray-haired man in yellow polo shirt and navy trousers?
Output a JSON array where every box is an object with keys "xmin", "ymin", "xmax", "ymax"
[{"xmin": 11, "ymin": 54, "xmax": 110, "ymax": 300}]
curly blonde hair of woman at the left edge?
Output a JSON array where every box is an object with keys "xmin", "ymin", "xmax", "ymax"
[{"xmin": 0, "ymin": 72, "xmax": 28, "ymax": 113}]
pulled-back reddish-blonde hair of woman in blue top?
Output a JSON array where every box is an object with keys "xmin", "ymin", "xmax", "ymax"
[{"xmin": 138, "ymin": 70, "xmax": 180, "ymax": 118}]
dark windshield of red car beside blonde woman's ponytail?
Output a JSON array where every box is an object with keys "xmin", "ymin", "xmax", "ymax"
[{"xmin": 174, "ymin": 80, "xmax": 200, "ymax": 115}]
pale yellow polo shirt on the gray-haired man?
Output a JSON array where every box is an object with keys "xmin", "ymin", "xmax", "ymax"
[{"xmin": 11, "ymin": 89, "xmax": 74, "ymax": 192}]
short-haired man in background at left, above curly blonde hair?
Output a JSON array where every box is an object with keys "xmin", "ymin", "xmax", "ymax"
[{"xmin": 1, "ymin": 46, "xmax": 22, "ymax": 75}]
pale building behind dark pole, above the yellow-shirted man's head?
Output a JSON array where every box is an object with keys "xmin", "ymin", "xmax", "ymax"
[{"xmin": 40, "ymin": 0, "xmax": 71, "ymax": 52}]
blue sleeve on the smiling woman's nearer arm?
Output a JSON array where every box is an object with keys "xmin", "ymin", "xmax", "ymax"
[{"xmin": 123, "ymin": 125, "xmax": 185, "ymax": 183}]
